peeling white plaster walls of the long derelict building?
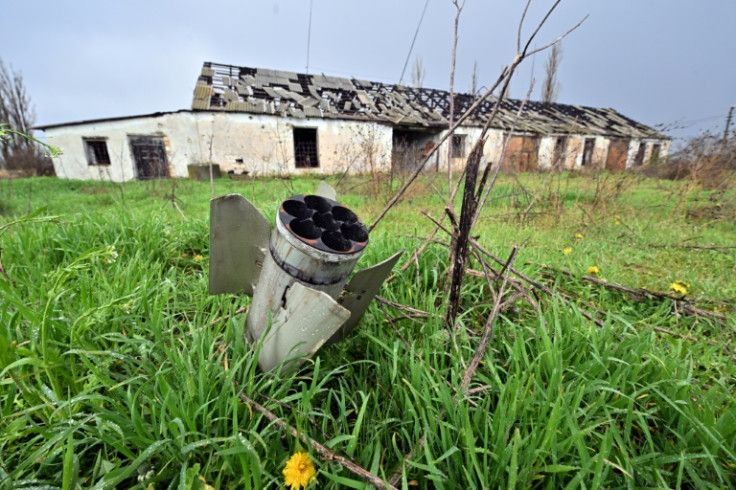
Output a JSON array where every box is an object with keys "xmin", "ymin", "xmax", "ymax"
[{"xmin": 45, "ymin": 111, "xmax": 669, "ymax": 181}]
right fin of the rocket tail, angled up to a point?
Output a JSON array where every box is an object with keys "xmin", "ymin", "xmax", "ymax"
[{"xmin": 329, "ymin": 250, "xmax": 404, "ymax": 344}]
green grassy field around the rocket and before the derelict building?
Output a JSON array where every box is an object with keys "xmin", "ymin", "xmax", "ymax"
[{"xmin": 0, "ymin": 170, "xmax": 736, "ymax": 489}]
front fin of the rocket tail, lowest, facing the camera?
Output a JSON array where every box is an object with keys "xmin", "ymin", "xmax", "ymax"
[{"xmin": 258, "ymin": 282, "xmax": 350, "ymax": 371}]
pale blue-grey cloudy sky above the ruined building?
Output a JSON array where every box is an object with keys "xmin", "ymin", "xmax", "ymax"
[{"xmin": 0, "ymin": 0, "xmax": 736, "ymax": 145}]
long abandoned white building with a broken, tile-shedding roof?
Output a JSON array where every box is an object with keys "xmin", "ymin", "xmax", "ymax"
[{"xmin": 37, "ymin": 62, "xmax": 670, "ymax": 181}]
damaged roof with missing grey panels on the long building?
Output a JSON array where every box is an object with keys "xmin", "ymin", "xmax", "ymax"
[{"xmin": 192, "ymin": 62, "xmax": 666, "ymax": 139}]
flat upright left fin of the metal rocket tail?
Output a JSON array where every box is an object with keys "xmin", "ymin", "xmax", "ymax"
[{"xmin": 209, "ymin": 194, "xmax": 271, "ymax": 295}]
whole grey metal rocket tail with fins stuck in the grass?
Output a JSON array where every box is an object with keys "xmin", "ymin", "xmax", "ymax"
[{"xmin": 210, "ymin": 188, "xmax": 403, "ymax": 371}]
